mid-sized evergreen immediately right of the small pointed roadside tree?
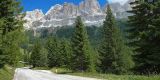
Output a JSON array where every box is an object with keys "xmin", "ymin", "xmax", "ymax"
[{"xmin": 46, "ymin": 37, "xmax": 63, "ymax": 67}]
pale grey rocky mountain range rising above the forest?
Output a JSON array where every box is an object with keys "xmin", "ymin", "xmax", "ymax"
[{"xmin": 24, "ymin": 0, "xmax": 130, "ymax": 29}]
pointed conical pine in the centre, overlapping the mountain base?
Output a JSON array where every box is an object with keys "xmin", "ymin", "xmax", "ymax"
[{"xmin": 71, "ymin": 17, "xmax": 94, "ymax": 71}]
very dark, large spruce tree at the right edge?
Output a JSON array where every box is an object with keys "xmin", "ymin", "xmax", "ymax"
[{"xmin": 128, "ymin": 0, "xmax": 160, "ymax": 74}]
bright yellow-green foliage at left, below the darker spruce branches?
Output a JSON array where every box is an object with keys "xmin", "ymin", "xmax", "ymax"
[{"xmin": 2, "ymin": 30, "xmax": 23, "ymax": 66}]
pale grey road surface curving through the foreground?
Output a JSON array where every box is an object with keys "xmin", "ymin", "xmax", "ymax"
[{"xmin": 13, "ymin": 68, "xmax": 100, "ymax": 80}]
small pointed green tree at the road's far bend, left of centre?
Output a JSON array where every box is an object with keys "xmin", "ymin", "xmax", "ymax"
[{"xmin": 30, "ymin": 41, "xmax": 48, "ymax": 67}]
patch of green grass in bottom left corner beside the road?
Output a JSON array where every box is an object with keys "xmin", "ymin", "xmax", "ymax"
[{"xmin": 0, "ymin": 66, "xmax": 15, "ymax": 80}]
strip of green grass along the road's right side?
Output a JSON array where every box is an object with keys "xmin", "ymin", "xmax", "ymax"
[{"xmin": 51, "ymin": 68, "xmax": 160, "ymax": 80}]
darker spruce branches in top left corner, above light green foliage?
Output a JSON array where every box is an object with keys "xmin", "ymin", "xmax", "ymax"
[{"xmin": 0, "ymin": 0, "xmax": 24, "ymax": 35}]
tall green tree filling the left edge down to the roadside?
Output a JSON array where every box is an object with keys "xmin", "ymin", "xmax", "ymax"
[{"xmin": 0, "ymin": 0, "xmax": 23, "ymax": 66}]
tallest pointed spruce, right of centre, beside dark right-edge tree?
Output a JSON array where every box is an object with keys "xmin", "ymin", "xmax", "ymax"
[{"xmin": 99, "ymin": 5, "xmax": 133, "ymax": 74}]
